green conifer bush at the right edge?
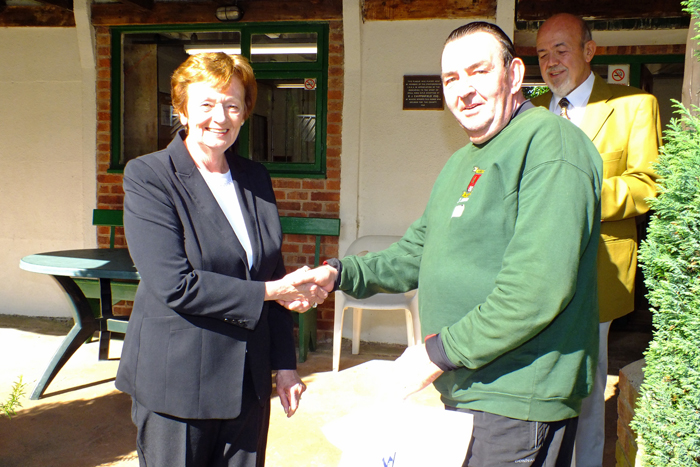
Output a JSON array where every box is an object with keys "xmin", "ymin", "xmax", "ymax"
[{"xmin": 632, "ymin": 82, "xmax": 700, "ymax": 467}]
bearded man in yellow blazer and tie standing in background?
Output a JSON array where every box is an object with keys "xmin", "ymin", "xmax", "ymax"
[{"xmin": 532, "ymin": 14, "xmax": 661, "ymax": 467}]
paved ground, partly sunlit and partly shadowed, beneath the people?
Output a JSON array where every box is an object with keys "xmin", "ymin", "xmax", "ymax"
[{"xmin": 0, "ymin": 315, "xmax": 649, "ymax": 467}]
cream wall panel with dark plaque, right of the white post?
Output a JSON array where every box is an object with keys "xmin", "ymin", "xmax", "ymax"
[{"xmin": 358, "ymin": 21, "xmax": 468, "ymax": 235}]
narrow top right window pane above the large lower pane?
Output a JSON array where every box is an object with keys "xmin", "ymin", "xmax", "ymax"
[{"xmin": 250, "ymin": 32, "xmax": 318, "ymax": 63}]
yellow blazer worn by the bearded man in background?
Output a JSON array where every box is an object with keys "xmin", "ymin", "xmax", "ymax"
[{"xmin": 532, "ymin": 75, "xmax": 661, "ymax": 322}]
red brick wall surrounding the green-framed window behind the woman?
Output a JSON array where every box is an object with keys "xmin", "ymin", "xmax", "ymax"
[{"xmin": 95, "ymin": 21, "xmax": 344, "ymax": 342}]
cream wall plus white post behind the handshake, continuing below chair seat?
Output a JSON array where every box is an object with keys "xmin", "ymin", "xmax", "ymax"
[{"xmin": 340, "ymin": 18, "xmax": 482, "ymax": 344}]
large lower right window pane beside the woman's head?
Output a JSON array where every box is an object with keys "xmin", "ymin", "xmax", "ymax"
[{"xmin": 250, "ymin": 78, "xmax": 316, "ymax": 163}]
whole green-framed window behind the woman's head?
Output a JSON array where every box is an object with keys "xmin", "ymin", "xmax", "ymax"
[{"xmin": 111, "ymin": 23, "xmax": 328, "ymax": 178}]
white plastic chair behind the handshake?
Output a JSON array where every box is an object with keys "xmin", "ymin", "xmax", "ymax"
[{"xmin": 333, "ymin": 235, "xmax": 422, "ymax": 371}]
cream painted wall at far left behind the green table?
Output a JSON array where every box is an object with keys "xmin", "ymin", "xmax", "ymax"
[{"xmin": 0, "ymin": 28, "xmax": 95, "ymax": 316}]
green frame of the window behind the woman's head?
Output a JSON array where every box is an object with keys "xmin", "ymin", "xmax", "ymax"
[{"xmin": 108, "ymin": 22, "xmax": 329, "ymax": 178}]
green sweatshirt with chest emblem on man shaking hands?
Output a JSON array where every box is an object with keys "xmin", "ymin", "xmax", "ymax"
[{"xmin": 340, "ymin": 108, "xmax": 603, "ymax": 421}]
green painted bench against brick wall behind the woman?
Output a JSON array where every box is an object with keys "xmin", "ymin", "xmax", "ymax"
[{"xmin": 83, "ymin": 209, "xmax": 340, "ymax": 362}]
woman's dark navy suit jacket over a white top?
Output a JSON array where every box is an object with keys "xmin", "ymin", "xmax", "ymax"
[{"xmin": 116, "ymin": 133, "xmax": 296, "ymax": 419}]
